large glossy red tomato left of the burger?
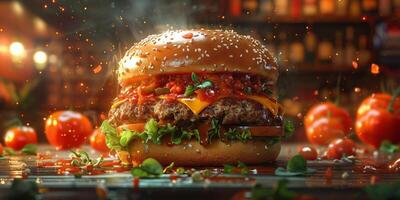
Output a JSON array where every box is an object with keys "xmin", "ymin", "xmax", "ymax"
[{"xmin": 45, "ymin": 111, "xmax": 93, "ymax": 149}]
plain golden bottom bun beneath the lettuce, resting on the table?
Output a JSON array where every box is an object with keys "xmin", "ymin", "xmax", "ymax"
[{"xmin": 129, "ymin": 140, "xmax": 281, "ymax": 166}]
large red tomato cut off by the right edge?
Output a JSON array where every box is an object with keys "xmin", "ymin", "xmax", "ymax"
[{"xmin": 356, "ymin": 94, "xmax": 400, "ymax": 148}]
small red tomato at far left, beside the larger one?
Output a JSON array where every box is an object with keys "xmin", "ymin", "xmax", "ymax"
[{"xmin": 4, "ymin": 126, "xmax": 37, "ymax": 151}]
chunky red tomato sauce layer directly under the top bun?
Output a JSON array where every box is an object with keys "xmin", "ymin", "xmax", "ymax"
[{"xmin": 115, "ymin": 73, "xmax": 273, "ymax": 104}]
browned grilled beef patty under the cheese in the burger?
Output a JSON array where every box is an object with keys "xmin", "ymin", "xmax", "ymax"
[{"xmin": 108, "ymin": 98, "xmax": 282, "ymax": 126}]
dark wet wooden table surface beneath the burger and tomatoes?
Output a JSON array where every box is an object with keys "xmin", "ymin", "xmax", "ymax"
[{"xmin": 0, "ymin": 144, "xmax": 400, "ymax": 199}]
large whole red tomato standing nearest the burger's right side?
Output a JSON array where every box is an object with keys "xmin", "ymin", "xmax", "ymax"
[{"xmin": 304, "ymin": 102, "xmax": 352, "ymax": 145}]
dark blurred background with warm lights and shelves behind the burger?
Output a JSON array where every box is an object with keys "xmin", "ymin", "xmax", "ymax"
[{"xmin": 0, "ymin": 0, "xmax": 400, "ymax": 141}]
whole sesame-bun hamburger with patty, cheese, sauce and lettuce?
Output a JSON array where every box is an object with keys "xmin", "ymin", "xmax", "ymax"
[{"xmin": 101, "ymin": 29, "xmax": 283, "ymax": 166}]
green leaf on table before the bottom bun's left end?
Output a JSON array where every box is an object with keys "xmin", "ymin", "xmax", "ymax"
[{"xmin": 131, "ymin": 158, "xmax": 163, "ymax": 178}]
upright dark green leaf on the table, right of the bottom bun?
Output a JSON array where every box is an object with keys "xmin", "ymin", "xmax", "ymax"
[{"xmin": 275, "ymin": 155, "xmax": 316, "ymax": 176}]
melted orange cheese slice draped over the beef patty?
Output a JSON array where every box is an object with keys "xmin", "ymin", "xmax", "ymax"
[{"xmin": 160, "ymin": 95, "xmax": 281, "ymax": 115}]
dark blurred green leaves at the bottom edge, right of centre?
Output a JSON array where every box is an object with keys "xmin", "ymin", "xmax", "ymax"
[{"xmin": 251, "ymin": 179, "xmax": 297, "ymax": 200}]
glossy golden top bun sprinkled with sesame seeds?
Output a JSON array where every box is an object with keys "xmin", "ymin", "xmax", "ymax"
[{"xmin": 117, "ymin": 29, "xmax": 278, "ymax": 85}]
